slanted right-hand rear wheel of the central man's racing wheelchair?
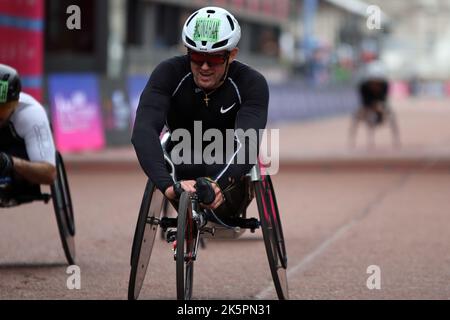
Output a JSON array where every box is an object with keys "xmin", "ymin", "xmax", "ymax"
[{"xmin": 255, "ymin": 176, "xmax": 289, "ymax": 300}]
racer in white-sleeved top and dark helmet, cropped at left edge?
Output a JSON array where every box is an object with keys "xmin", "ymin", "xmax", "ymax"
[{"xmin": 0, "ymin": 64, "xmax": 56, "ymax": 200}]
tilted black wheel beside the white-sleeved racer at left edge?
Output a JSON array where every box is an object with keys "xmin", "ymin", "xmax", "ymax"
[{"xmin": 50, "ymin": 152, "xmax": 75, "ymax": 265}]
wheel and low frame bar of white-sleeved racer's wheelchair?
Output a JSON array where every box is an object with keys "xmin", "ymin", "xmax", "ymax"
[{"xmin": 0, "ymin": 151, "xmax": 75, "ymax": 265}]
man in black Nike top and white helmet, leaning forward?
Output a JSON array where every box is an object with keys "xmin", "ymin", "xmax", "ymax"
[{"xmin": 132, "ymin": 7, "xmax": 269, "ymax": 218}]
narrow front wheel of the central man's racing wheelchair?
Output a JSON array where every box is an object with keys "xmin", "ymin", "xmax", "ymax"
[{"xmin": 176, "ymin": 192, "xmax": 197, "ymax": 300}]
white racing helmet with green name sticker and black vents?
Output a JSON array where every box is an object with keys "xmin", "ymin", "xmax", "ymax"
[{"xmin": 182, "ymin": 7, "xmax": 241, "ymax": 53}]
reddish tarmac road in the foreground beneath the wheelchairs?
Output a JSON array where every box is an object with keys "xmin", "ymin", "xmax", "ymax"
[{"xmin": 0, "ymin": 168, "xmax": 450, "ymax": 299}]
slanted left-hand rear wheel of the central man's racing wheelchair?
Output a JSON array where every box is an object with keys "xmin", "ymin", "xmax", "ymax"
[{"xmin": 128, "ymin": 180, "xmax": 164, "ymax": 300}]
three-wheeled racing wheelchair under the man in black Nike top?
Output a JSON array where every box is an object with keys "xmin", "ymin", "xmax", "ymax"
[{"xmin": 128, "ymin": 134, "xmax": 289, "ymax": 300}]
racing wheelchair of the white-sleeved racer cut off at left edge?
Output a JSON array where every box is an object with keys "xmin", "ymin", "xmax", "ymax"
[{"xmin": 0, "ymin": 151, "xmax": 75, "ymax": 265}]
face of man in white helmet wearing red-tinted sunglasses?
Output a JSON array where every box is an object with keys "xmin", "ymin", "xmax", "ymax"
[{"xmin": 190, "ymin": 48, "xmax": 239, "ymax": 90}]
